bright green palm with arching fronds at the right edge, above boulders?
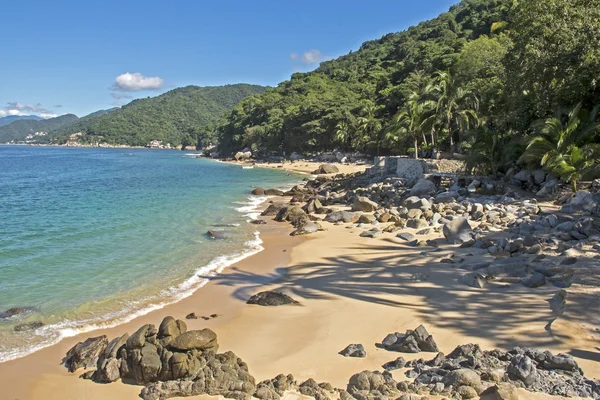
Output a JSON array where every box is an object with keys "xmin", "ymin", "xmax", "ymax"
[{"xmin": 519, "ymin": 103, "xmax": 600, "ymax": 191}]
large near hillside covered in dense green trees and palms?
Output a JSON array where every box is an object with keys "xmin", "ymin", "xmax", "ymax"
[{"xmin": 218, "ymin": 0, "xmax": 600, "ymax": 158}]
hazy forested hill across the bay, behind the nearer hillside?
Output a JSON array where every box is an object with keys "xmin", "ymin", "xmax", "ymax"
[{"xmin": 50, "ymin": 84, "xmax": 266, "ymax": 146}]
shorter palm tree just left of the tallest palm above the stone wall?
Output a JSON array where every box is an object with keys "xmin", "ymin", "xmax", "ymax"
[{"xmin": 386, "ymin": 91, "xmax": 435, "ymax": 159}]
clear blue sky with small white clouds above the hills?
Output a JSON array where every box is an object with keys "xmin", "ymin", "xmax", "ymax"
[{"xmin": 0, "ymin": 0, "xmax": 457, "ymax": 117}]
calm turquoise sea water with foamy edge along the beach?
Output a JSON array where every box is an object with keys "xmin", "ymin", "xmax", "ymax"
[{"xmin": 0, "ymin": 146, "xmax": 298, "ymax": 362}]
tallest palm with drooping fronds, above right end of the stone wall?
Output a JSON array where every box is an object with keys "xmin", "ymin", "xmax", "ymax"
[{"xmin": 435, "ymin": 71, "xmax": 479, "ymax": 148}]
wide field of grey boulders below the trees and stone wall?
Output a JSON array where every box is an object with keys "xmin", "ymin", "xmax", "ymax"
[{"xmin": 253, "ymin": 166, "xmax": 600, "ymax": 296}]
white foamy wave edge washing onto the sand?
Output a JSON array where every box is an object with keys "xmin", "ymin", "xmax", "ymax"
[{"xmin": 0, "ymin": 232, "xmax": 264, "ymax": 363}]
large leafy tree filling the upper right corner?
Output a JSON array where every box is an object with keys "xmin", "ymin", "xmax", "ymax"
[{"xmin": 506, "ymin": 0, "xmax": 600, "ymax": 127}]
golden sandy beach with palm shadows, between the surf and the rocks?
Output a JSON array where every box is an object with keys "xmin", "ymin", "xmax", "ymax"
[{"xmin": 0, "ymin": 185, "xmax": 600, "ymax": 400}]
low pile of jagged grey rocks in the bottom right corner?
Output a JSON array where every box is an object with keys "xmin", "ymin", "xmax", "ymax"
[{"xmin": 399, "ymin": 344, "xmax": 600, "ymax": 399}]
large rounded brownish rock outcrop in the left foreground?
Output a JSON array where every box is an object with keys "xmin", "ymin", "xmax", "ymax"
[{"xmin": 63, "ymin": 317, "xmax": 256, "ymax": 400}]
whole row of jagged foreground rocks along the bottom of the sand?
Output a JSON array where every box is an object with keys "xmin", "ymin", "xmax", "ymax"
[{"xmin": 63, "ymin": 317, "xmax": 600, "ymax": 400}]
